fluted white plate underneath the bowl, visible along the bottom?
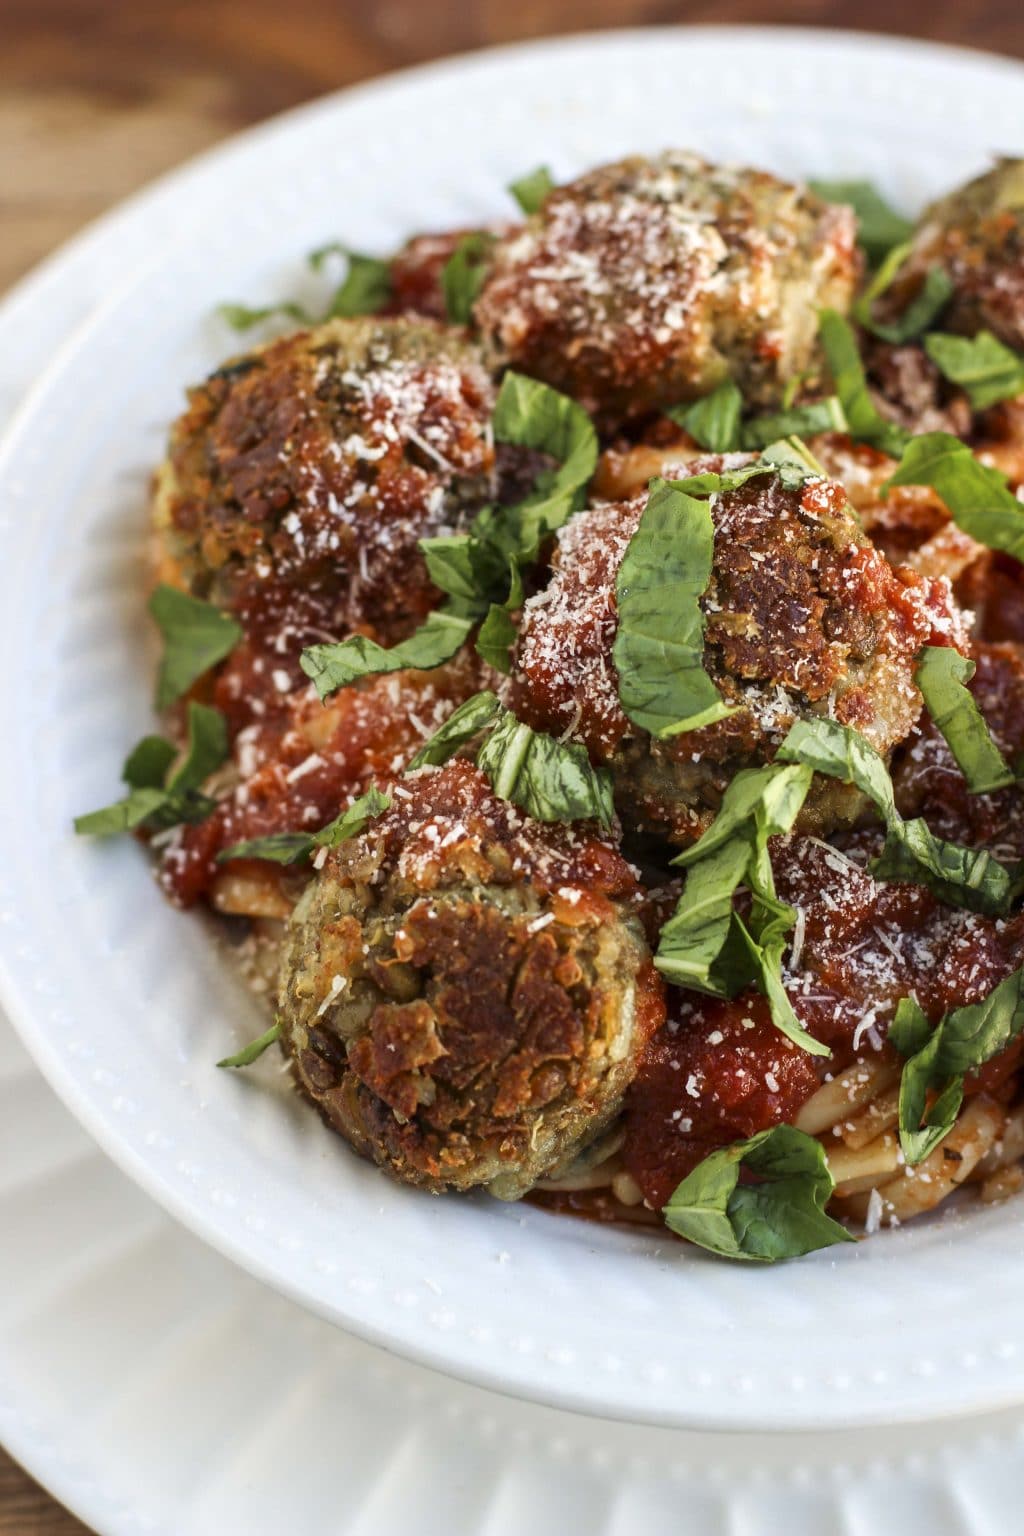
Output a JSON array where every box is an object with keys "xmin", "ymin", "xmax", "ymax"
[{"xmin": 10, "ymin": 1015, "xmax": 1024, "ymax": 1536}]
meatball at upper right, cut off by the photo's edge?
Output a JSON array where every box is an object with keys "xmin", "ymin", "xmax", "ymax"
[{"xmin": 878, "ymin": 160, "xmax": 1024, "ymax": 349}]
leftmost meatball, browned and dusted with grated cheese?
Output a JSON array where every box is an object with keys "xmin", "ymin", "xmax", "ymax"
[{"xmin": 155, "ymin": 319, "xmax": 494, "ymax": 665}]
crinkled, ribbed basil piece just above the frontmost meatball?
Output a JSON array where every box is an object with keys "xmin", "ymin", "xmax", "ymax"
[{"xmin": 476, "ymin": 710, "xmax": 614, "ymax": 828}]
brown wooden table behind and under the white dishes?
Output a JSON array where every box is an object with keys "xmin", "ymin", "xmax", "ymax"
[{"xmin": 0, "ymin": 0, "xmax": 1024, "ymax": 1536}]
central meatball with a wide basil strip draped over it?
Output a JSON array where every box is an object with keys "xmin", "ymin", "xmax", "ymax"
[{"xmin": 510, "ymin": 455, "xmax": 961, "ymax": 843}]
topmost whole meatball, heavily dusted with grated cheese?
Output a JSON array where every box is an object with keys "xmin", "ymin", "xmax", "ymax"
[{"xmin": 474, "ymin": 151, "xmax": 858, "ymax": 425}]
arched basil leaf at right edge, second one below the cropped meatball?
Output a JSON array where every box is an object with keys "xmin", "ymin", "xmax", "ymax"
[{"xmin": 881, "ymin": 432, "xmax": 1024, "ymax": 561}]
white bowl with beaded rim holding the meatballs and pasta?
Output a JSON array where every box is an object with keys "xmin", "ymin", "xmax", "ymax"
[{"xmin": 0, "ymin": 31, "xmax": 1024, "ymax": 1427}]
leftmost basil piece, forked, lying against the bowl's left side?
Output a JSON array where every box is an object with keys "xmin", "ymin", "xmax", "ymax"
[{"xmin": 74, "ymin": 700, "xmax": 227, "ymax": 837}]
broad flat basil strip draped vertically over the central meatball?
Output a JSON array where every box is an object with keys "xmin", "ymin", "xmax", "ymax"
[{"xmin": 613, "ymin": 479, "xmax": 735, "ymax": 736}]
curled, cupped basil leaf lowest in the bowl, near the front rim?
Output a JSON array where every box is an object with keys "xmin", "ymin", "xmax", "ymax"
[{"xmin": 662, "ymin": 1126, "xmax": 855, "ymax": 1263}]
